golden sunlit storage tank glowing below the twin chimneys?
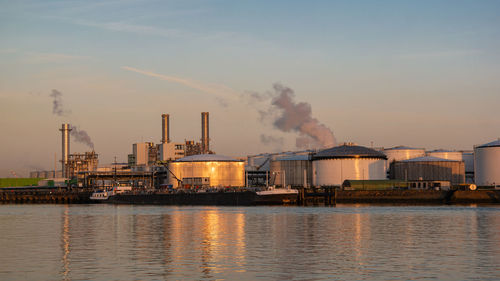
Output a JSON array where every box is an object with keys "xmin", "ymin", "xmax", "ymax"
[{"xmin": 168, "ymin": 154, "xmax": 245, "ymax": 187}]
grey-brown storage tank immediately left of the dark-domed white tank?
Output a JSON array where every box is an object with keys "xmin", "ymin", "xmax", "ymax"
[{"xmin": 269, "ymin": 155, "xmax": 312, "ymax": 187}]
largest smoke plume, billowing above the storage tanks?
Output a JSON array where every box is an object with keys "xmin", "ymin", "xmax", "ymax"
[{"xmin": 256, "ymin": 83, "xmax": 335, "ymax": 148}]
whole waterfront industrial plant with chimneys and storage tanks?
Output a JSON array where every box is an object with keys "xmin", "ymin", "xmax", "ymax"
[{"xmin": 2, "ymin": 105, "xmax": 500, "ymax": 206}]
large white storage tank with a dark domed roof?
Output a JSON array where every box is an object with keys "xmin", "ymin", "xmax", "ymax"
[{"xmin": 312, "ymin": 143, "xmax": 387, "ymax": 186}]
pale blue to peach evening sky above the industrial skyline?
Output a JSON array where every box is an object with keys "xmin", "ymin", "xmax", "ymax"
[{"xmin": 0, "ymin": 0, "xmax": 500, "ymax": 177}]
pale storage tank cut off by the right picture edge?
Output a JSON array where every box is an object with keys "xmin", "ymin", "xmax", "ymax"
[{"xmin": 474, "ymin": 139, "xmax": 500, "ymax": 186}]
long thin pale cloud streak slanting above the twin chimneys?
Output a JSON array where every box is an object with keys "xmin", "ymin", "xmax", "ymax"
[{"xmin": 122, "ymin": 66, "xmax": 240, "ymax": 99}]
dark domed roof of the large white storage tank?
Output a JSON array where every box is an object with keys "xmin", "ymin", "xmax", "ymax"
[{"xmin": 312, "ymin": 144, "xmax": 387, "ymax": 160}]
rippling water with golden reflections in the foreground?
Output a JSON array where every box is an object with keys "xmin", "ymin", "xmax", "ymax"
[{"xmin": 0, "ymin": 205, "xmax": 500, "ymax": 281}]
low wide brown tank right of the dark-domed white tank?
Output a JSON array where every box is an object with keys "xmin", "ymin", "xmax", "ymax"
[{"xmin": 390, "ymin": 156, "xmax": 465, "ymax": 185}]
